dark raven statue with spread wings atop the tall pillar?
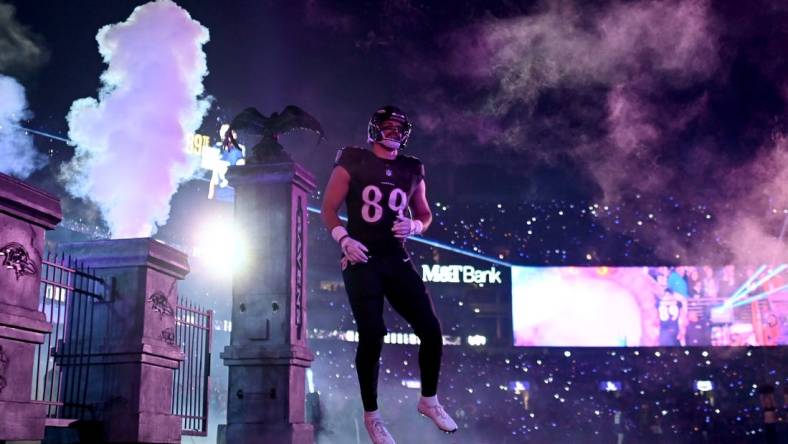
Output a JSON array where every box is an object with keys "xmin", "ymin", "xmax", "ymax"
[{"xmin": 224, "ymin": 105, "xmax": 325, "ymax": 164}]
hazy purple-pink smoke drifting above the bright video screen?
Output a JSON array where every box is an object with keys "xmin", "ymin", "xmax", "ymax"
[{"xmin": 428, "ymin": 0, "xmax": 788, "ymax": 263}]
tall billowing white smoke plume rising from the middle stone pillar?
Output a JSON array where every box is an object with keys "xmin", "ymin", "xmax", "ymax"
[{"xmin": 61, "ymin": 0, "xmax": 209, "ymax": 238}]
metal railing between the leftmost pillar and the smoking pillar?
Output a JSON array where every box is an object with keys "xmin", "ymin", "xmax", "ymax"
[{"xmin": 31, "ymin": 253, "xmax": 107, "ymax": 419}]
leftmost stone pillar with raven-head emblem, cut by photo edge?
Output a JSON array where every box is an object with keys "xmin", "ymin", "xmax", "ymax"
[{"xmin": 0, "ymin": 174, "xmax": 63, "ymax": 441}]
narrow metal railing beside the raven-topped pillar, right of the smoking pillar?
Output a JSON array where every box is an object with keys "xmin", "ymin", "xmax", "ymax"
[{"xmin": 172, "ymin": 299, "xmax": 213, "ymax": 436}]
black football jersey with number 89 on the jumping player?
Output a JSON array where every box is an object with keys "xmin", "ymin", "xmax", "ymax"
[{"xmin": 334, "ymin": 147, "xmax": 424, "ymax": 254}]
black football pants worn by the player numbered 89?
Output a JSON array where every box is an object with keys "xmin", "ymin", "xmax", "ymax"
[{"xmin": 342, "ymin": 251, "xmax": 443, "ymax": 412}]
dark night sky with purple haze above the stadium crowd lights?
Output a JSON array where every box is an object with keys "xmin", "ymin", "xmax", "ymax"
[{"xmin": 3, "ymin": 0, "xmax": 788, "ymax": 264}]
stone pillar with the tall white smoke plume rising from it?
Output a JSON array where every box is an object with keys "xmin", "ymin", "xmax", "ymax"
[{"xmin": 60, "ymin": 238, "xmax": 189, "ymax": 443}]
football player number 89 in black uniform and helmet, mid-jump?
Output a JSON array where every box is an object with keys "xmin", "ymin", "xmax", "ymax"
[{"xmin": 322, "ymin": 106, "xmax": 457, "ymax": 444}]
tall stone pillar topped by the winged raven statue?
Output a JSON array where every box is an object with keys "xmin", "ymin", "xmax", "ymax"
[{"xmin": 219, "ymin": 162, "xmax": 315, "ymax": 444}]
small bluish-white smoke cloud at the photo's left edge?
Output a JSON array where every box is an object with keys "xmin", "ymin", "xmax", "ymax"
[{"xmin": 0, "ymin": 74, "xmax": 46, "ymax": 179}]
